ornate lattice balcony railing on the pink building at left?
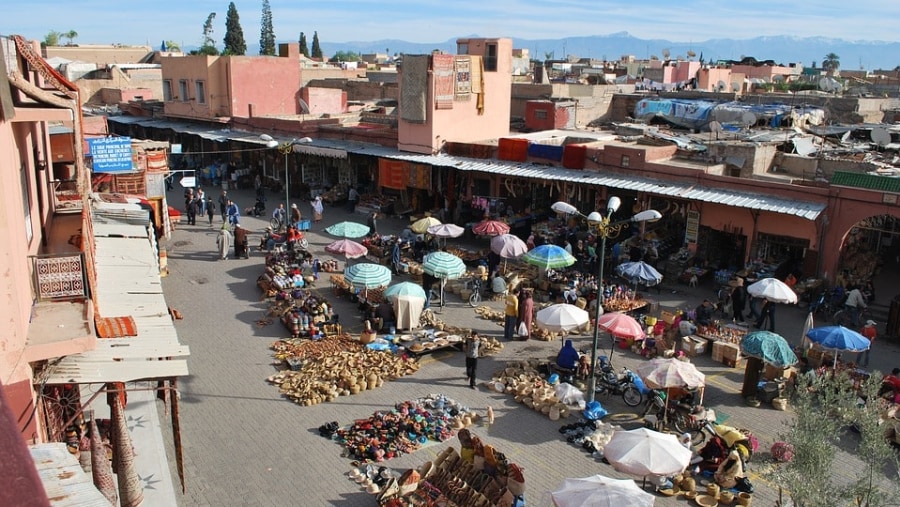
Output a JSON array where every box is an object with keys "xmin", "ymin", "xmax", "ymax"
[{"xmin": 32, "ymin": 252, "xmax": 88, "ymax": 301}]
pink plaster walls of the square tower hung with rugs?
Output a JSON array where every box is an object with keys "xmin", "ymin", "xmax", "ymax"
[{"xmin": 397, "ymin": 38, "xmax": 512, "ymax": 154}]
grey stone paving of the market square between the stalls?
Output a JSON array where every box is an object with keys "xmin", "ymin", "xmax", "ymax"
[{"xmin": 156, "ymin": 190, "xmax": 897, "ymax": 507}]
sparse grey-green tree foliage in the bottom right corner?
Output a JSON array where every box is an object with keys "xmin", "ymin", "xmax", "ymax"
[{"xmin": 764, "ymin": 372, "xmax": 896, "ymax": 507}]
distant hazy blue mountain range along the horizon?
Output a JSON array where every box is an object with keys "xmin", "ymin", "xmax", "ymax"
[{"xmin": 312, "ymin": 32, "xmax": 900, "ymax": 70}]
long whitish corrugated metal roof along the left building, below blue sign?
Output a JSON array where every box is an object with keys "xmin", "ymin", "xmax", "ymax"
[{"xmin": 46, "ymin": 211, "xmax": 190, "ymax": 384}]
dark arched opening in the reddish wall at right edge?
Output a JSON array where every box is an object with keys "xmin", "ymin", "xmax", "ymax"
[{"xmin": 835, "ymin": 215, "xmax": 900, "ymax": 307}]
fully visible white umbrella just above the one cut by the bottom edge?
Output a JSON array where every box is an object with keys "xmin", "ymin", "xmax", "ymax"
[{"xmin": 603, "ymin": 428, "xmax": 691, "ymax": 477}]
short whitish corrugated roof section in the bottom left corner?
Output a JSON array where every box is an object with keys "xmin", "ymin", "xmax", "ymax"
[{"xmin": 29, "ymin": 443, "xmax": 109, "ymax": 507}]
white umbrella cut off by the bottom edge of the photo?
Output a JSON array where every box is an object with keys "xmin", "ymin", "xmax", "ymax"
[{"xmin": 550, "ymin": 475, "xmax": 655, "ymax": 507}]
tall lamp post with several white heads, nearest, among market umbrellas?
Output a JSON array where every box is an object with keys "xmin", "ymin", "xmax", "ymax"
[{"xmin": 551, "ymin": 200, "xmax": 662, "ymax": 402}]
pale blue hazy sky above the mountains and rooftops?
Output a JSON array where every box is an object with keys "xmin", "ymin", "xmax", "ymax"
[{"xmin": 0, "ymin": 0, "xmax": 900, "ymax": 48}]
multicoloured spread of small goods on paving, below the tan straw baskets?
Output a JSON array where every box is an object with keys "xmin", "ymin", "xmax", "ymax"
[{"xmin": 332, "ymin": 395, "xmax": 468, "ymax": 463}]
